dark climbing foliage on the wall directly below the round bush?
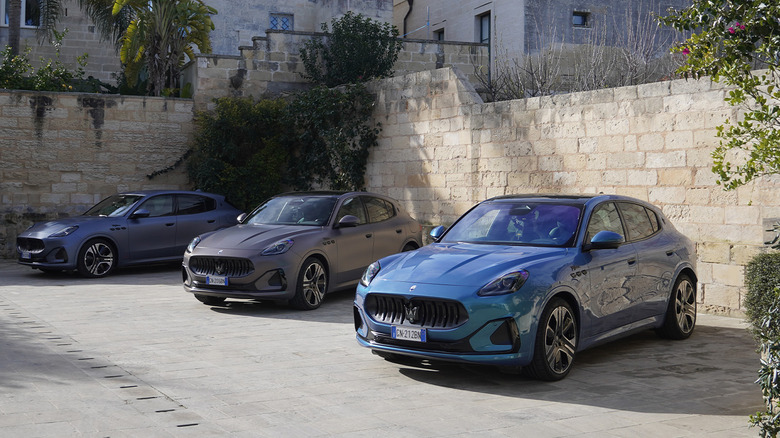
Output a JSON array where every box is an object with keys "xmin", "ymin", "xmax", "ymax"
[{"xmin": 288, "ymin": 84, "xmax": 379, "ymax": 190}]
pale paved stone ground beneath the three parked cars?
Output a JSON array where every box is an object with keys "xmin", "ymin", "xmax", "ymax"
[{"xmin": 0, "ymin": 261, "xmax": 761, "ymax": 438}]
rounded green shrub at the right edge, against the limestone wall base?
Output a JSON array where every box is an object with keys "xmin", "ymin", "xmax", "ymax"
[{"xmin": 745, "ymin": 252, "xmax": 780, "ymax": 334}]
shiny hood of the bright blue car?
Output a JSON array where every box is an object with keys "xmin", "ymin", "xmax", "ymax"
[{"xmin": 375, "ymin": 243, "xmax": 569, "ymax": 287}]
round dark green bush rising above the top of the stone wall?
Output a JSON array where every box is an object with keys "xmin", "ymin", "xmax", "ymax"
[{"xmin": 300, "ymin": 12, "xmax": 403, "ymax": 87}]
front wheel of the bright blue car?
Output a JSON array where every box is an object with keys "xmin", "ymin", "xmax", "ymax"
[{"xmin": 523, "ymin": 298, "xmax": 578, "ymax": 381}]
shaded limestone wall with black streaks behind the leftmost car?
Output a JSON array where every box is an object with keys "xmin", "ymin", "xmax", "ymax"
[{"xmin": 0, "ymin": 91, "xmax": 193, "ymax": 258}]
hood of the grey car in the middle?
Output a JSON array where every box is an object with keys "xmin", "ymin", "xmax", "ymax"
[{"xmin": 198, "ymin": 225, "xmax": 322, "ymax": 249}]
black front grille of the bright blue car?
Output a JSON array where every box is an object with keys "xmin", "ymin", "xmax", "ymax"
[{"xmin": 365, "ymin": 294, "xmax": 469, "ymax": 328}]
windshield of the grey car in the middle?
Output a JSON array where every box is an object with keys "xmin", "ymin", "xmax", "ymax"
[{"xmin": 244, "ymin": 196, "xmax": 336, "ymax": 227}]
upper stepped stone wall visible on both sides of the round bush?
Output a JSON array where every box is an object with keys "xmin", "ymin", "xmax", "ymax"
[{"xmin": 182, "ymin": 30, "xmax": 488, "ymax": 109}]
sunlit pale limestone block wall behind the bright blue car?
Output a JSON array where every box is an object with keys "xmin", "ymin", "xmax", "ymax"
[{"xmin": 367, "ymin": 68, "xmax": 780, "ymax": 313}]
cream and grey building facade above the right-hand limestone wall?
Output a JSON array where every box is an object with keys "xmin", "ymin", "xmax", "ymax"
[{"xmin": 394, "ymin": 0, "xmax": 691, "ymax": 80}]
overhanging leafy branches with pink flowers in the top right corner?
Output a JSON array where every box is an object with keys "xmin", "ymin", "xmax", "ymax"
[{"xmin": 659, "ymin": 0, "xmax": 780, "ymax": 189}]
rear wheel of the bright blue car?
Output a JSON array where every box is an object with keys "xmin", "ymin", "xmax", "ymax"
[{"xmin": 658, "ymin": 274, "xmax": 696, "ymax": 340}]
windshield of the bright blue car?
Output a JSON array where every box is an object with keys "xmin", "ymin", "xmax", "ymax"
[{"xmin": 441, "ymin": 201, "xmax": 581, "ymax": 247}]
